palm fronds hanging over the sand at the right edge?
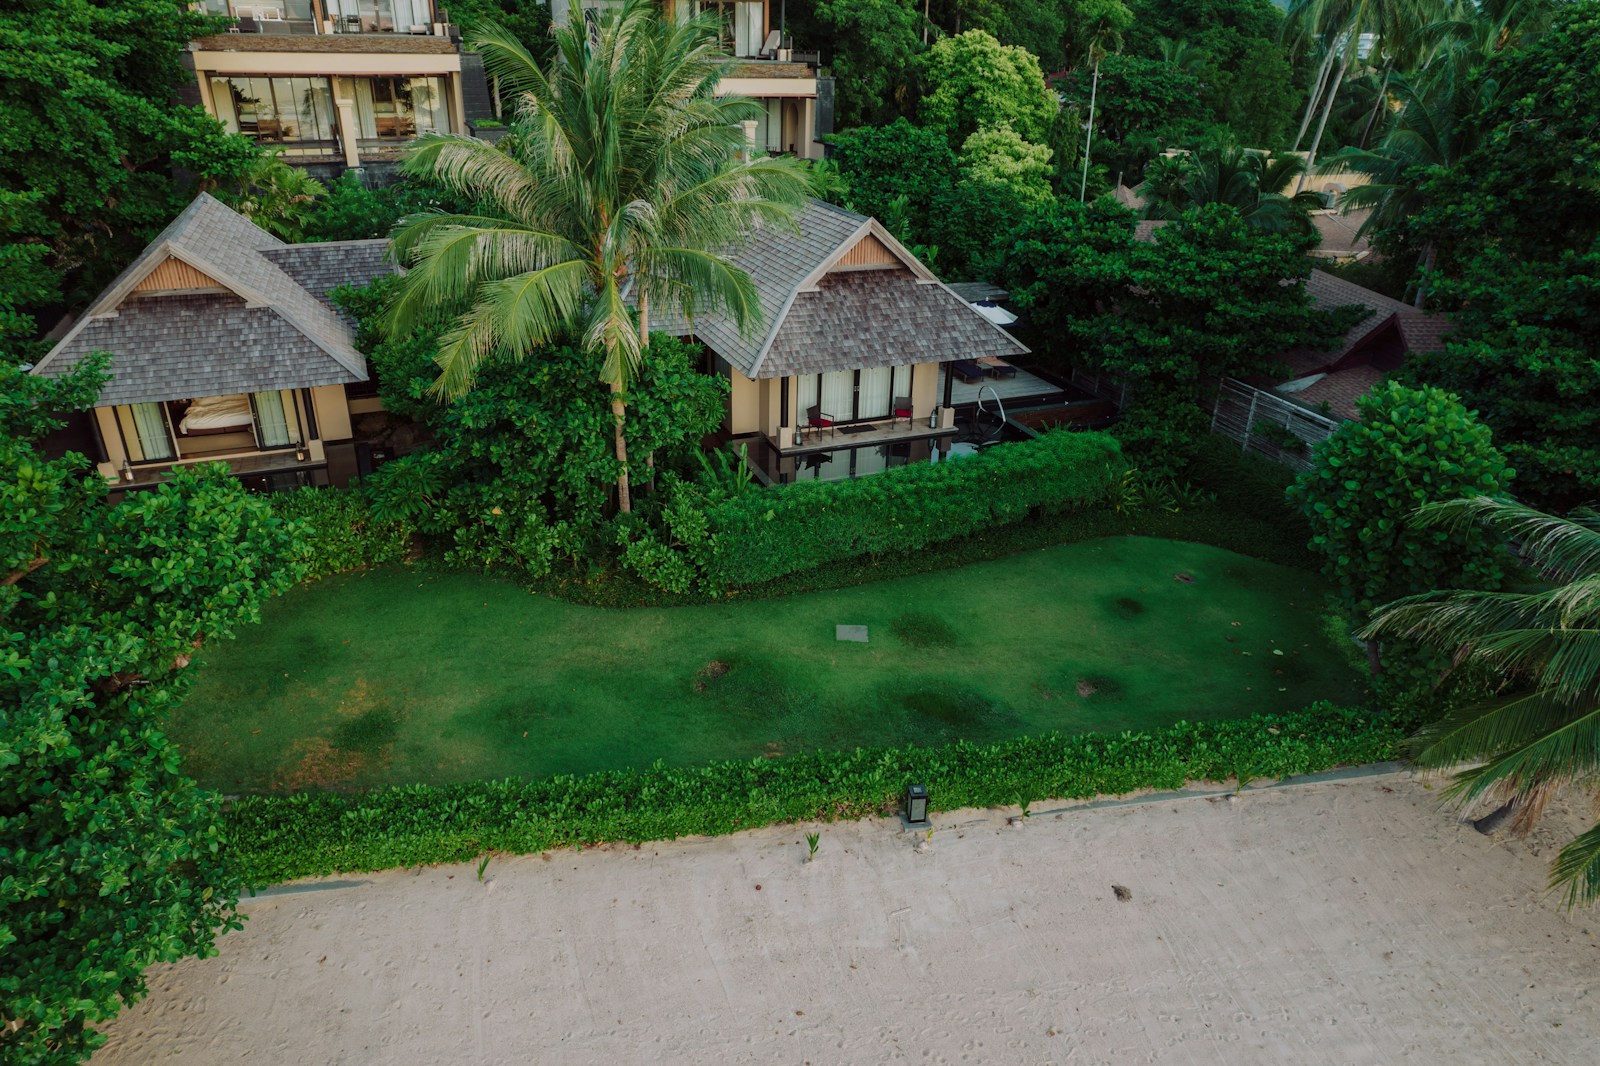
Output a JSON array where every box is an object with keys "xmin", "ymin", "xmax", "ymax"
[{"xmin": 1360, "ymin": 496, "xmax": 1600, "ymax": 906}]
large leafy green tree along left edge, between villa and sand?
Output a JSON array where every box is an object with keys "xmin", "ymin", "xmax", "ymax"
[{"xmin": 0, "ymin": 356, "xmax": 298, "ymax": 1063}]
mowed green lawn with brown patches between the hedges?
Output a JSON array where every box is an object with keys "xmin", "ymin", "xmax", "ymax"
[{"xmin": 170, "ymin": 538, "xmax": 1358, "ymax": 792}]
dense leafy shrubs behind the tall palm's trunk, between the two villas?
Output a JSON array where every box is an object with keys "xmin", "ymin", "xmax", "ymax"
[{"xmin": 350, "ymin": 270, "xmax": 728, "ymax": 576}]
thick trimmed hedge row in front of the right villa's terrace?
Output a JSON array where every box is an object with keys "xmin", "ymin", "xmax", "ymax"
[{"xmin": 667, "ymin": 432, "xmax": 1125, "ymax": 586}]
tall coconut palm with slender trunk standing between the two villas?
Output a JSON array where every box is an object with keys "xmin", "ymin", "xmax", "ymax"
[{"xmin": 387, "ymin": 0, "xmax": 808, "ymax": 512}]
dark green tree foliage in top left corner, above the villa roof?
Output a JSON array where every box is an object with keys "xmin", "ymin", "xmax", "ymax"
[{"xmin": 0, "ymin": 0, "xmax": 258, "ymax": 352}]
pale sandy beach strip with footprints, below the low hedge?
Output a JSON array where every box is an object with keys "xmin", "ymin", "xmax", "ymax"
[{"xmin": 94, "ymin": 775, "xmax": 1600, "ymax": 1066}]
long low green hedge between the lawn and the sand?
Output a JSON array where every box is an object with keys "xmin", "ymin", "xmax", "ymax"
[{"xmin": 224, "ymin": 703, "xmax": 1414, "ymax": 885}]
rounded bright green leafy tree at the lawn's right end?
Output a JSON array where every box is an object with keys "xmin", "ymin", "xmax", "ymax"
[{"xmin": 1290, "ymin": 381, "xmax": 1512, "ymax": 619}]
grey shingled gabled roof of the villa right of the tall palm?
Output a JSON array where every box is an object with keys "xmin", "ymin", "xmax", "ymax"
[{"xmin": 650, "ymin": 200, "xmax": 1027, "ymax": 378}]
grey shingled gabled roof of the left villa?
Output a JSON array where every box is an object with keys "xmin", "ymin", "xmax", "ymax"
[{"xmin": 34, "ymin": 194, "xmax": 379, "ymax": 405}]
